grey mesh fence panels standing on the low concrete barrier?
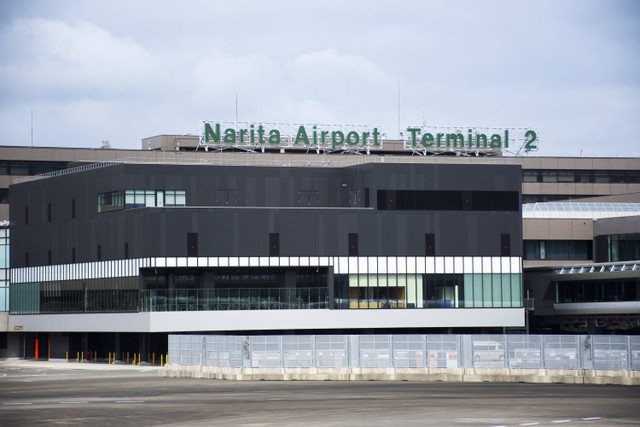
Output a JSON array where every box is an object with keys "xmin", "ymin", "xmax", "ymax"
[{"xmin": 168, "ymin": 335, "xmax": 640, "ymax": 370}]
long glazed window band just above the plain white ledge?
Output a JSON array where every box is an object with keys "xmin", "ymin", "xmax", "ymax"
[{"xmin": 10, "ymin": 274, "xmax": 522, "ymax": 314}]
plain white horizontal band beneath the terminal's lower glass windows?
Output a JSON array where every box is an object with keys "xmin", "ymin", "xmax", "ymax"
[{"xmin": 9, "ymin": 308, "xmax": 524, "ymax": 332}]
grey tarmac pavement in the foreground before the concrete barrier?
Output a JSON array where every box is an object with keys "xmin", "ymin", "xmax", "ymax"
[{"xmin": 0, "ymin": 360, "xmax": 640, "ymax": 427}]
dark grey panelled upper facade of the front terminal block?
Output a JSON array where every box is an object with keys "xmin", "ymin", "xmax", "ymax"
[{"xmin": 10, "ymin": 164, "xmax": 522, "ymax": 268}]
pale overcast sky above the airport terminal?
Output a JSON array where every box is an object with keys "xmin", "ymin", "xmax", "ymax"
[{"xmin": 0, "ymin": 0, "xmax": 640, "ymax": 157}]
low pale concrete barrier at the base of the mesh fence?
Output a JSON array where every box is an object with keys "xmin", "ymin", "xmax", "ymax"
[{"xmin": 158, "ymin": 365, "xmax": 640, "ymax": 385}]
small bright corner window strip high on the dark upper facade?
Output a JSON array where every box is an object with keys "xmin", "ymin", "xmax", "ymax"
[{"xmin": 98, "ymin": 190, "xmax": 187, "ymax": 213}]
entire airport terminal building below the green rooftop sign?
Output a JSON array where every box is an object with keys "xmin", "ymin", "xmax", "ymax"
[{"xmin": 0, "ymin": 125, "xmax": 640, "ymax": 357}]
